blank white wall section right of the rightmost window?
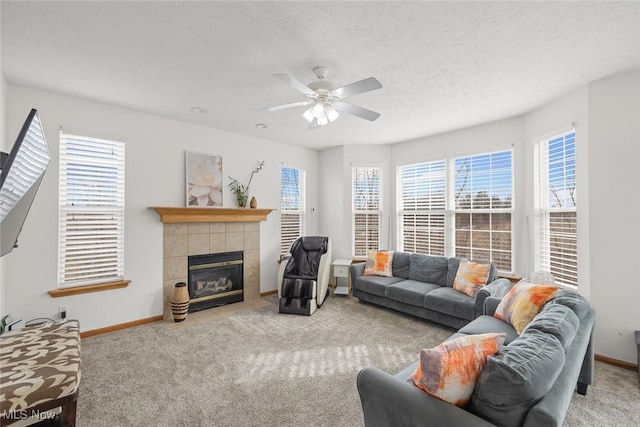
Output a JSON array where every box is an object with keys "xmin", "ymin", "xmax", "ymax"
[{"xmin": 578, "ymin": 72, "xmax": 640, "ymax": 363}]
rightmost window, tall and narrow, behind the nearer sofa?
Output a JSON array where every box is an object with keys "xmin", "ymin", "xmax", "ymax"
[{"xmin": 534, "ymin": 130, "xmax": 578, "ymax": 286}]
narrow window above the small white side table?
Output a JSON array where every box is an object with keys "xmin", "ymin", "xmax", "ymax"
[{"xmin": 351, "ymin": 167, "xmax": 382, "ymax": 257}]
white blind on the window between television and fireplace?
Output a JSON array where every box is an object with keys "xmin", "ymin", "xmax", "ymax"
[{"xmin": 58, "ymin": 131, "xmax": 124, "ymax": 288}]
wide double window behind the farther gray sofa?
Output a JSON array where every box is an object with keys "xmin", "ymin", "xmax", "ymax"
[{"xmin": 398, "ymin": 150, "xmax": 513, "ymax": 272}]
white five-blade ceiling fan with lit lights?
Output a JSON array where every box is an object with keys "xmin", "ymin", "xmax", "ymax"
[{"xmin": 260, "ymin": 66, "xmax": 382, "ymax": 129}]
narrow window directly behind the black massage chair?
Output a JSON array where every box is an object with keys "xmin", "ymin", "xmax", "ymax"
[{"xmin": 280, "ymin": 167, "xmax": 305, "ymax": 255}]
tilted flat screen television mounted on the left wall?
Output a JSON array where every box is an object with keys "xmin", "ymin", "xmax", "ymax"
[{"xmin": 0, "ymin": 109, "xmax": 51, "ymax": 256}]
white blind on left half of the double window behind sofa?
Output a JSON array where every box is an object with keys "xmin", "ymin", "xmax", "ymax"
[{"xmin": 398, "ymin": 160, "xmax": 446, "ymax": 255}]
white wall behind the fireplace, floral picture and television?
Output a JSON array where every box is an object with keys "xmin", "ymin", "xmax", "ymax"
[{"xmin": 2, "ymin": 85, "xmax": 319, "ymax": 330}]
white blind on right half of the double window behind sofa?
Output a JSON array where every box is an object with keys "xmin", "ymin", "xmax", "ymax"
[{"xmin": 452, "ymin": 150, "xmax": 513, "ymax": 271}]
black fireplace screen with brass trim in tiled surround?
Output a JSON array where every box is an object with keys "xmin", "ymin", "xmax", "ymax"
[{"xmin": 189, "ymin": 251, "xmax": 244, "ymax": 312}]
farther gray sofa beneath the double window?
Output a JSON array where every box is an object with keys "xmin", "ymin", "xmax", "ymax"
[{"xmin": 351, "ymin": 252, "xmax": 512, "ymax": 329}]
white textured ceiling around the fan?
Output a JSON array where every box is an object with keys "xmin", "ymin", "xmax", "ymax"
[{"xmin": 0, "ymin": 1, "xmax": 640, "ymax": 149}]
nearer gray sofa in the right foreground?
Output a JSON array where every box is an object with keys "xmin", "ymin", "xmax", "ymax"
[{"xmin": 357, "ymin": 291, "xmax": 595, "ymax": 427}]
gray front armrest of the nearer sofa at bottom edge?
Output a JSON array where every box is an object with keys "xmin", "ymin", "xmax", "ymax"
[{"xmin": 358, "ymin": 367, "xmax": 493, "ymax": 427}]
